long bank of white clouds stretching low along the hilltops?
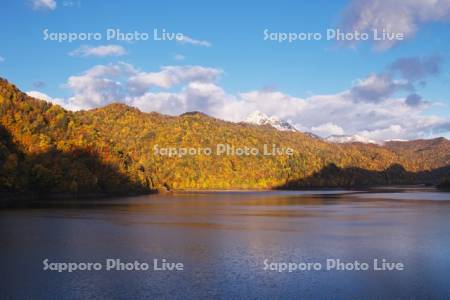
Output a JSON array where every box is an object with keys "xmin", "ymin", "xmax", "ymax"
[{"xmin": 53, "ymin": 63, "xmax": 450, "ymax": 140}]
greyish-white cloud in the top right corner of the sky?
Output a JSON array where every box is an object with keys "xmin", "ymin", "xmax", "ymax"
[{"xmin": 341, "ymin": 0, "xmax": 450, "ymax": 49}]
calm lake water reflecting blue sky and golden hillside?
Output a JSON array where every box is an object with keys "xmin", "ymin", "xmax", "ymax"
[{"xmin": 0, "ymin": 188, "xmax": 450, "ymax": 299}]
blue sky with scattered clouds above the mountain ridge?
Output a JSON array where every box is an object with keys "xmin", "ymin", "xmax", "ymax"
[{"xmin": 0, "ymin": 0, "xmax": 450, "ymax": 140}]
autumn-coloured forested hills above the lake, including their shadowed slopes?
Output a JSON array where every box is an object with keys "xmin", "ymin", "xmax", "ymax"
[{"xmin": 0, "ymin": 78, "xmax": 450, "ymax": 195}]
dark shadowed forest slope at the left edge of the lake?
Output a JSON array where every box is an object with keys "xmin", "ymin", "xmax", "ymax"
[{"xmin": 0, "ymin": 126, "xmax": 151, "ymax": 197}]
